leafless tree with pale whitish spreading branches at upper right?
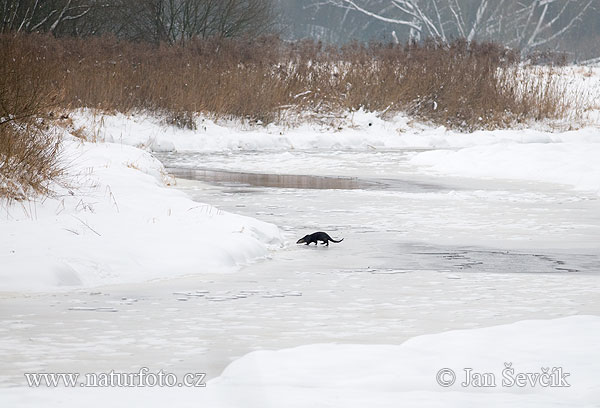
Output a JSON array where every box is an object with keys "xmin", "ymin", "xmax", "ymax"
[{"xmin": 314, "ymin": 0, "xmax": 598, "ymax": 53}]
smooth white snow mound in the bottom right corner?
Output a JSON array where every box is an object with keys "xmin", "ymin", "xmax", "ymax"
[{"xmin": 209, "ymin": 316, "xmax": 600, "ymax": 407}]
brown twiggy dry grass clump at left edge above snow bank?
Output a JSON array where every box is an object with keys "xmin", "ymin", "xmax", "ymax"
[{"xmin": 0, "ymin": 37, "xmax": 63, "ymax": 201}]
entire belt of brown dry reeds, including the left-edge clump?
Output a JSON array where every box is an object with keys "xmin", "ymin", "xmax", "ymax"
[{"xmin": 0, "ymin": 35, "xmax": 566, "ymax": 197}]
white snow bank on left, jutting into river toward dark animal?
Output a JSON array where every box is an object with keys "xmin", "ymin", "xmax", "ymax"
[{"xmin": 0, "ymin": 137, "xmax": 281, "ymax": 291}]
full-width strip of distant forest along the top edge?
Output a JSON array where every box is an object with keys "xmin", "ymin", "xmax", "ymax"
[{"xmin": 0, "ymin": 0, "xmax": 600, "ymax": 61}]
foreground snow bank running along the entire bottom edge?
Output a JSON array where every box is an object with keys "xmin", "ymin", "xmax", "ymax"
[{"xmin": 0, "ymin": 316, "xmax": 600, "ymax": 408}]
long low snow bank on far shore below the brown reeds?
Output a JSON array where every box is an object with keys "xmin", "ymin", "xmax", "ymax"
[{"xmin": 72, "ymin": 110, "xmax": 600, "ymax": 152}]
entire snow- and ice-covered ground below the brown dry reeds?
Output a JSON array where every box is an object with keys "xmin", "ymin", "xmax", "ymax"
[{"xmin": 0, "ymin": 65, "xmax": 600, "ymax": 407}]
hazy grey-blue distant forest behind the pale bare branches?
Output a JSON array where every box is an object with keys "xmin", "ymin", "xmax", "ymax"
[{"xmin": 278, "ymin": 0, "xmax": 600, "ymax": 61}]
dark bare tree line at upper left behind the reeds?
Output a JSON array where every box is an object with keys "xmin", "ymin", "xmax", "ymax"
[{"xmin": 0, "ymin": 0, "xmax": 276, "ymax": 44}]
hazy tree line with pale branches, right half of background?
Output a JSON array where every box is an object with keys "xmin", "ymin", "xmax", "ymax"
[{"xmin": 292, "ymin": 0, "xmax": 600, "ymax": 56}]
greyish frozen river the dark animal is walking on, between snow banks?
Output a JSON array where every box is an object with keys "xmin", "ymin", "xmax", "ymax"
[{"xmin": 0, "ymin": 151, "xmax": 600, "ymax": 386}]
